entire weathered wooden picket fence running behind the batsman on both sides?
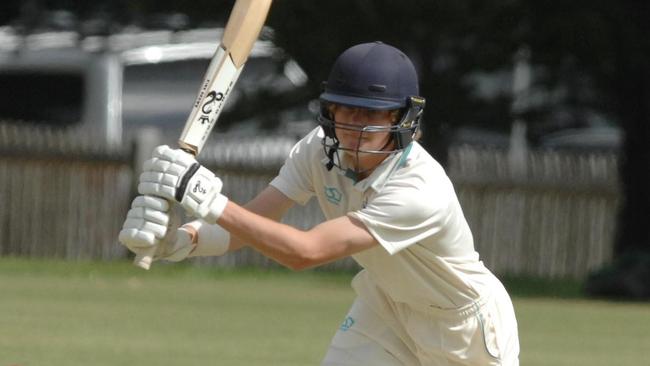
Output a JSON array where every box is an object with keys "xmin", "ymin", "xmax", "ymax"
[{"xmin": 0, "ymin": 123, "xmax": 620, "ymax": 279}]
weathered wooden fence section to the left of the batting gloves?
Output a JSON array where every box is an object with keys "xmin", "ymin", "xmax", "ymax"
[{"xmin": 0, "ymin": 125, "xmax": 133, "ymax": 259}]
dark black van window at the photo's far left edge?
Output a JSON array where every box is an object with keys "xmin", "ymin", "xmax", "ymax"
[{"xmin": 0, "ymin": 71, "xmax": 84, "ymax": 126}]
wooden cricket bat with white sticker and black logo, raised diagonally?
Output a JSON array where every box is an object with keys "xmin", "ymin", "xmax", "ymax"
[{"xmin": 134, "ymin": 0, "xmax": 271, "ymax": 269}]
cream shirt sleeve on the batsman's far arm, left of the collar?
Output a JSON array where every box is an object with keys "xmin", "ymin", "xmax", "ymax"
[{"xmin": 270, "ymin": 128, "xmax": 320, "ymax": 205}]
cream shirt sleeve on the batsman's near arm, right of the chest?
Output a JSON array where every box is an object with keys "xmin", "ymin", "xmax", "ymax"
[{"xmin": 348, "ymin": 169, "xmax": 451, "ymax": 255}]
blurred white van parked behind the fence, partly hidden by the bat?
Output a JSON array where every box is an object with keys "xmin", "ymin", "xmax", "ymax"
[{"xmin": 0, "ymin": 27, "xmax": 311, "ymax": 145}]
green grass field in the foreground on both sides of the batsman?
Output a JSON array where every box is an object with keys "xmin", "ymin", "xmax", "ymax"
[{"xmin": 0, "ymin": 258, "xmax": 650, "ymax": 366}]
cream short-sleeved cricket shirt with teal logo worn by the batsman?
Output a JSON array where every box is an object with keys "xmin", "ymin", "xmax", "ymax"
[{"xmin": 270, "ymin": 127, "xmax": 494, "ymax": 309}]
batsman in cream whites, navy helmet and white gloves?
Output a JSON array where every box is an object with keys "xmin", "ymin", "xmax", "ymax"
[{"xmin": 120, "ymin": 42, "xmax": 519, "ymax": 366}]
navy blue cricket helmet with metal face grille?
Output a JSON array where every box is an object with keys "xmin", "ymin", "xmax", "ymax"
[{"xmin": 318, "ymin": 42, "xmax": 425, "ymax": 172}]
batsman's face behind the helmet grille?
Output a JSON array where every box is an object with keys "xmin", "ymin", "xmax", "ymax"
[{"xmin": 332, "ymin": 105, "xmax": 394, "ymax": 155}]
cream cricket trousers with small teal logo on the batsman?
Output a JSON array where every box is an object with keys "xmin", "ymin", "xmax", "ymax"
[{"xmin": 322, "ymin": 281, "xmax": 519, "ymax": 366}]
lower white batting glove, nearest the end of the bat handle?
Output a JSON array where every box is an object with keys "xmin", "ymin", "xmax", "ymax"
[{"xmin": 119, "ymin": 196, "xmax": 195, "ymax": 262}]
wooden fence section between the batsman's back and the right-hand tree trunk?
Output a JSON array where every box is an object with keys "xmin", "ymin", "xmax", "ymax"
[{"xmin": 449, "ymin": 146, "xmax": 620, "ymax": 278}]
